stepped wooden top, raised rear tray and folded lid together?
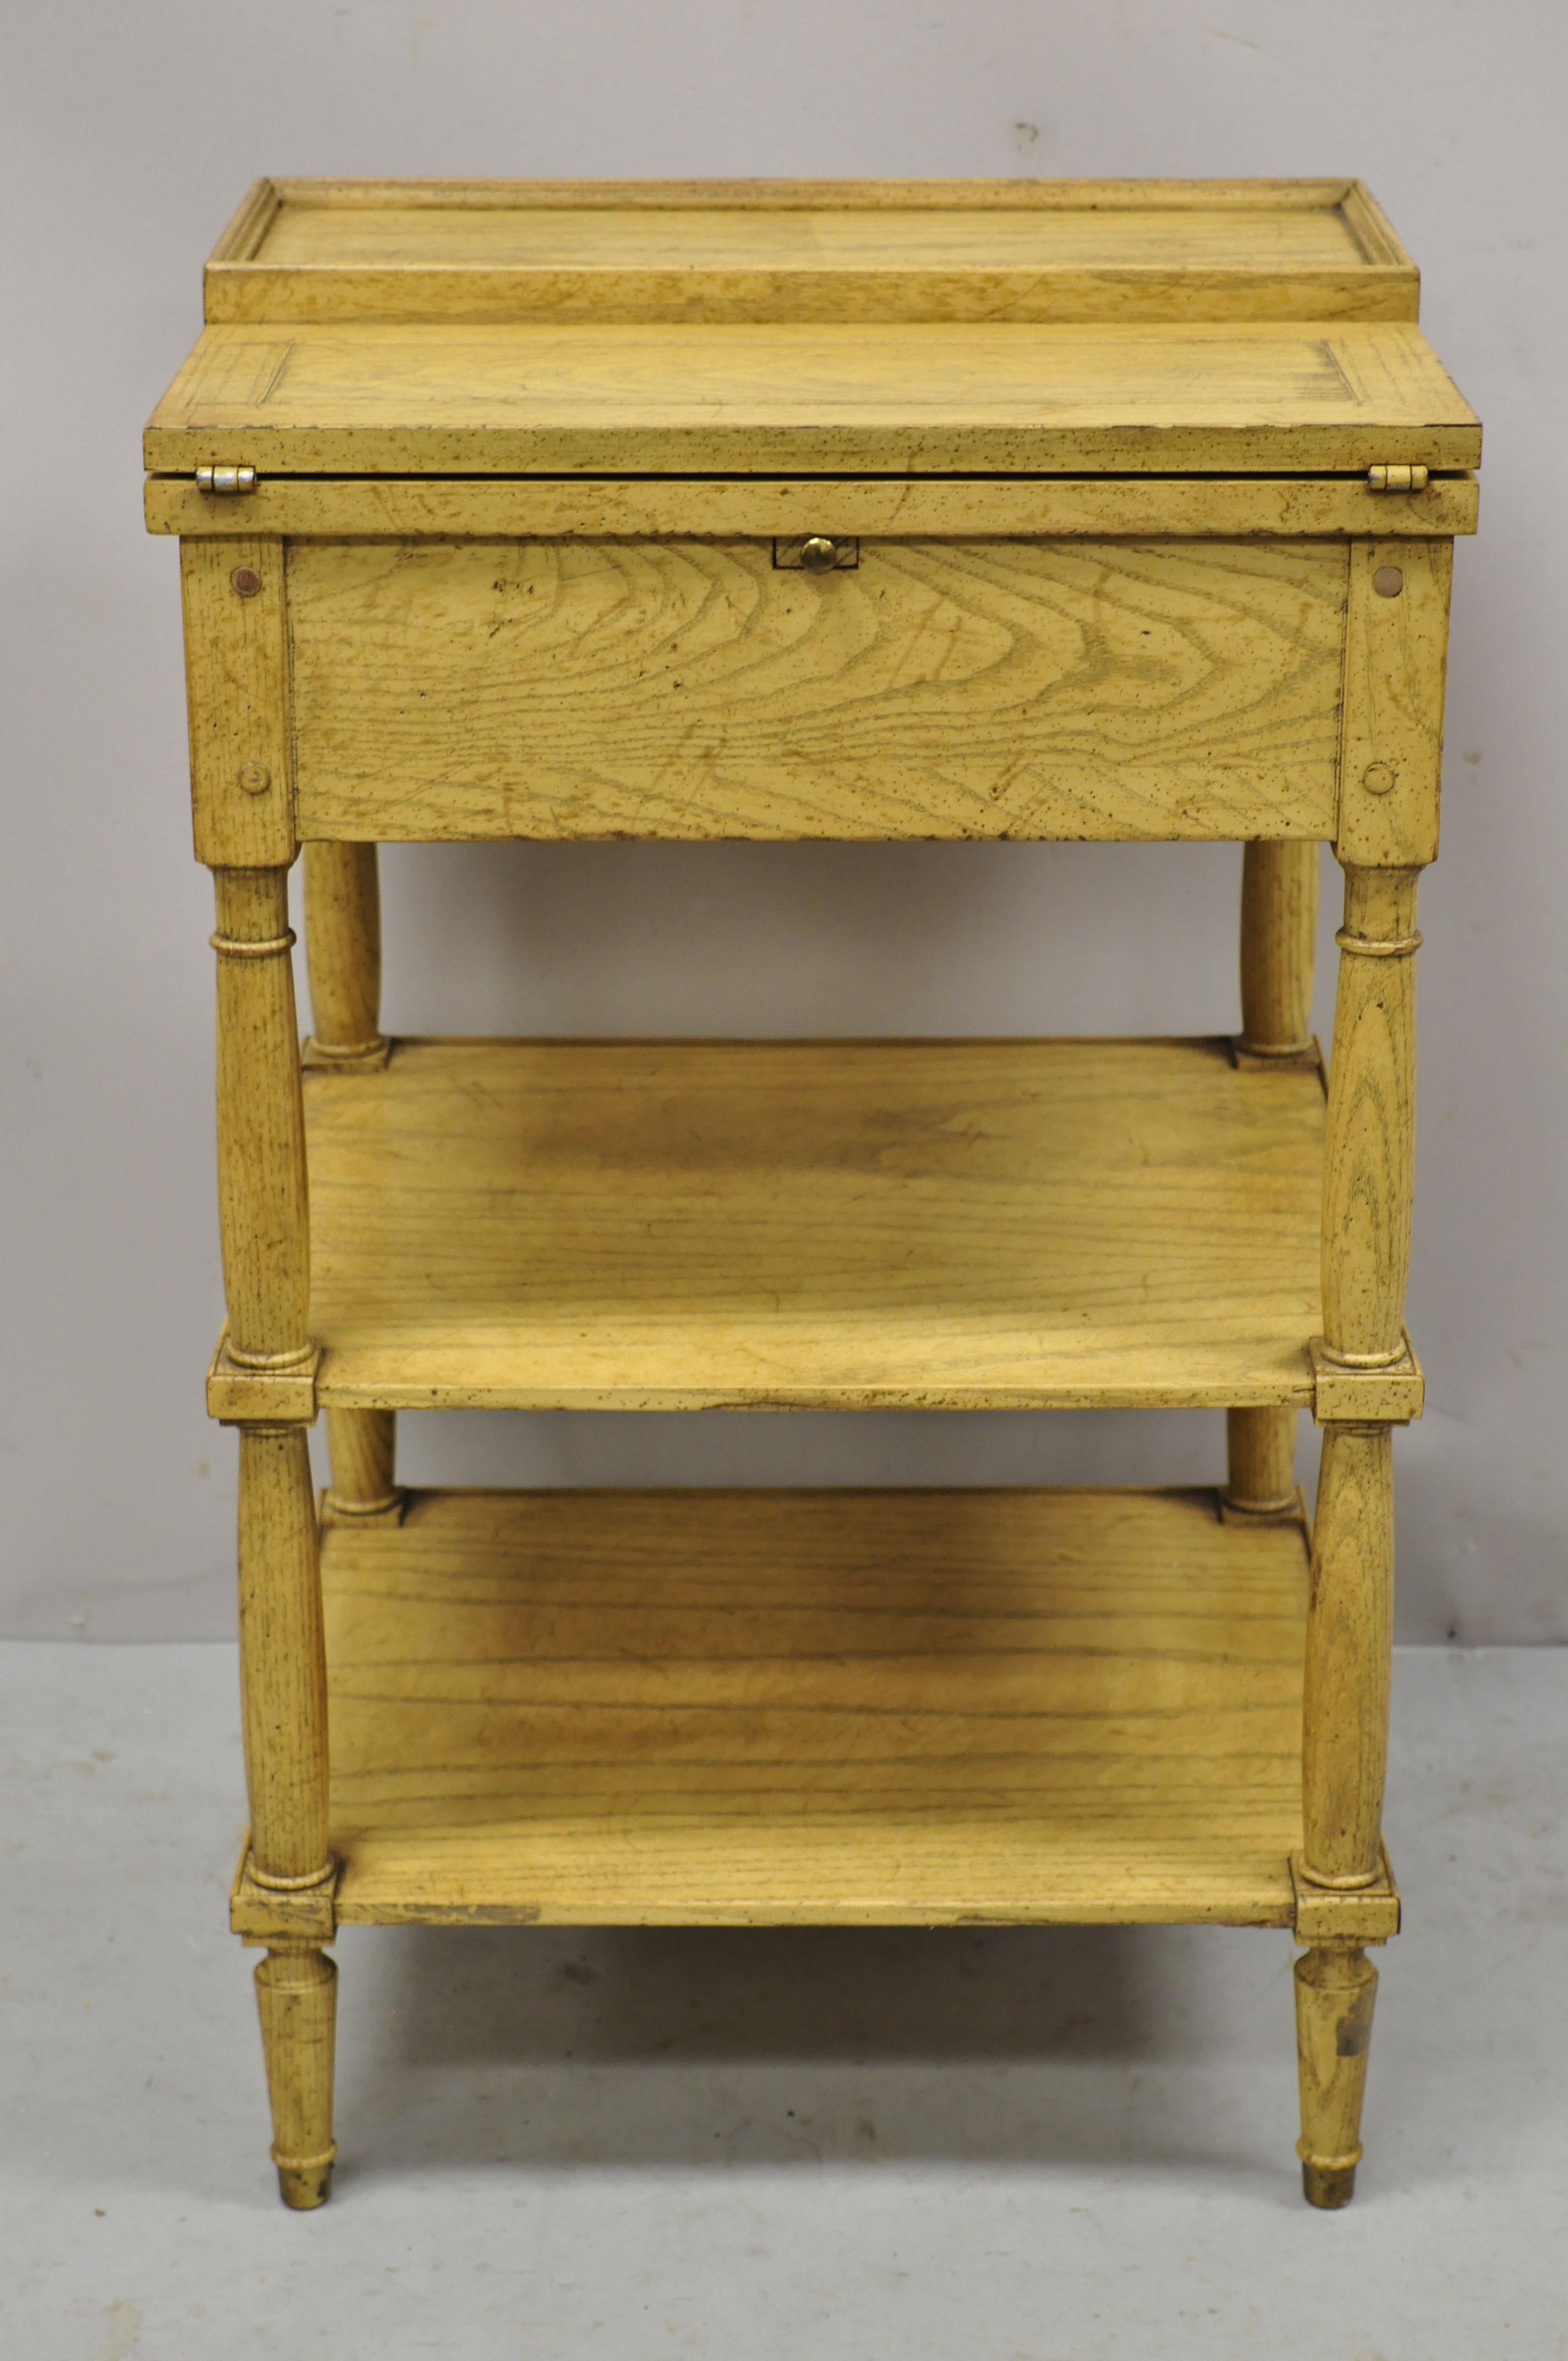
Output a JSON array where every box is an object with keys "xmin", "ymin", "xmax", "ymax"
[{"xmin": 146, "ymin": 182, "xmax": 1480, "ymax": 477}]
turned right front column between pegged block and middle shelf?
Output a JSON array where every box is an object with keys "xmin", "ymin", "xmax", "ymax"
[{"xmin": 1322, "ymin": 869, "xmax": 1422, "ymax": 1369}]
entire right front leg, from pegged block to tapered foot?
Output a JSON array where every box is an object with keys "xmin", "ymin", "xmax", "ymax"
[{"xmin": 1297, "ymin": 538, "xmax": 1452, "ymax": 2207}]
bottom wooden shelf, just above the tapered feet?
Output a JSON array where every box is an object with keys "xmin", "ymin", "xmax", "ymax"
[{"xmin": 321, "ymin": 1490, "xmax": 1308, "ymax": 1927}]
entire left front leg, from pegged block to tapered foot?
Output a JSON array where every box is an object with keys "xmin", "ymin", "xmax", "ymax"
[{"xmin": 179, "ymin": 534, "xmax": 337, "ymax": 2207}]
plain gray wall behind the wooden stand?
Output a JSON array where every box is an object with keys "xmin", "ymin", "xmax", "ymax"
[{"xmin": 0, "ymin": 0, "xmax": 1568, "ymax": 1641}]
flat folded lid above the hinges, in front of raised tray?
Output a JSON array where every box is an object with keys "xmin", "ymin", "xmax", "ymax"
[{"xmin": 144, "ymin": 321, "xmax": 1480, "ymax": 475}]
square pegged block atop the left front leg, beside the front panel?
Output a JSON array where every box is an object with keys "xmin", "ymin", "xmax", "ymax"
[{"xmin": 179, "ymin": 536, "xmax": 297, "ymax": 869}]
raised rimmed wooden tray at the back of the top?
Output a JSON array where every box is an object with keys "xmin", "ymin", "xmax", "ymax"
[{"xmin": 205, "ymin": 179, "xmax": 1419, "ymax": 326}]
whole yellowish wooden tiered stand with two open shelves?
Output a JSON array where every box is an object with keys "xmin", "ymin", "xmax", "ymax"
[{"xmin": 146, "ymin": 182, "xmax": 1480, "ymax": 2205}]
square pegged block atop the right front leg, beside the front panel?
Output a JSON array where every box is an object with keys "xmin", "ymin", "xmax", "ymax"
[{"xmin": 1334, "ymin": 536, "xmax": 1455, "ymax": 869}]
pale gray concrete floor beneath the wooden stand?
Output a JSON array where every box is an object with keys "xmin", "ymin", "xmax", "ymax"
[{"xmin": 0, "ymin": 1643, "xmax": 1568, "ymax": 2361}]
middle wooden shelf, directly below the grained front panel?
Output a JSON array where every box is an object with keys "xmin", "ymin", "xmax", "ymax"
[{"xmin": 304, "ymin": 1039, "xmax": 1325, "ymax": 1410}]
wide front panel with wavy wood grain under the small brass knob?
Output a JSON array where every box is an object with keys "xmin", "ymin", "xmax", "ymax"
[{"xmin": 288, "ymin": 538, "xmax": 1348, "ymax": 841}]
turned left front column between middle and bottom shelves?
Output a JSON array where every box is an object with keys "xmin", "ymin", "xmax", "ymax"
[{"xmin": 238, "ymin": 1426, "xmax": 335, "ymax": 1891}]
